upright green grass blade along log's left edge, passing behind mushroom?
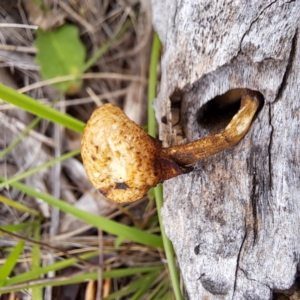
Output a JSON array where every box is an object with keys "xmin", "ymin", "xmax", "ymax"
[{"xmin": 148, "ymin": 34, "xmax": 183, "ymax": 300}]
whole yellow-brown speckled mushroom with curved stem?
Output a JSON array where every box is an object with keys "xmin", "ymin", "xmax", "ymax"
[{"xmin": 81, "ymin": 93, "xmax": 259, "ymax": 203}]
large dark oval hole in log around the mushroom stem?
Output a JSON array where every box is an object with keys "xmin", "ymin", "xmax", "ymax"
[{"xmin": 196, "ymin": 88, "xmax": 263, "ymax": 134}]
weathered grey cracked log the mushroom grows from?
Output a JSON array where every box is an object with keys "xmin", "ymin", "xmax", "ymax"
[{"xmin": 152, "ymin": 0, "xmax": 300, "ymax": 300}]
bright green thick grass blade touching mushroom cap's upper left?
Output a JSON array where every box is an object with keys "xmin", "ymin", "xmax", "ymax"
[{"xmin": 0, "ymin": 84, "xmax": 85, "ymax": 133}]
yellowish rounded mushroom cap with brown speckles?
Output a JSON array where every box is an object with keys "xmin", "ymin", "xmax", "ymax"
[{"xmin": 81, "ymin": 104, "xmax": 161, "ymax": 203}]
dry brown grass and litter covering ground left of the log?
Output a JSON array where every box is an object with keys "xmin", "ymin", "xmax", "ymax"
[{"xmin": 0, "ymin": 0, "xmax": 170, "ymax": 300}]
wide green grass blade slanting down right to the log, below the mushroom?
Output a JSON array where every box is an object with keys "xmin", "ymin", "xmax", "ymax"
[{"xmin": 0, "ymin": 177, "xmax": 163, "ymax": 248}]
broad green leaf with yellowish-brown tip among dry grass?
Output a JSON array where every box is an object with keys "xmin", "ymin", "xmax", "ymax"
[{"xmin": 35, "ymin": 25, "xmax": 85, "ymax": 94}]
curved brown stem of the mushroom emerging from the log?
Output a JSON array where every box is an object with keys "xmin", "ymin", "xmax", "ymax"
[{"xmin": 162, "ymin": 94, "xmax": 259, "ymax": 166}]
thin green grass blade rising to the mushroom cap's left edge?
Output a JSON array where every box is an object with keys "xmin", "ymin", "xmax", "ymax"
[{"xmin": 0, "ymin": 150, "xmax": 80, "ymax": 190}]
